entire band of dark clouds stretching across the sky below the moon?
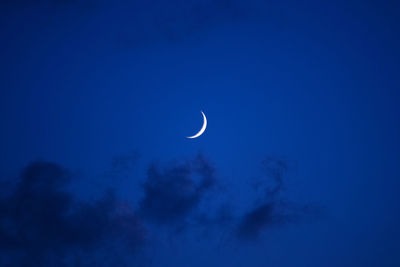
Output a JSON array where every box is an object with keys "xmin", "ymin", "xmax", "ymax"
[{"xmin": 0, "ymin": 155, "xmax": 314, "ymax": 266}]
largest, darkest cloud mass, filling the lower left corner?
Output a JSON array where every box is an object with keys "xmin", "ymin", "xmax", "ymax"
[{"xmin": 0, "ymin": 162, "xmax": 146, "ymax": 266}]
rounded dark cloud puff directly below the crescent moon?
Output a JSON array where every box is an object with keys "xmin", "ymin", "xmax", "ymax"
[{"xmin": 139, "ymin": 155, "xmax": 215, "ymax": 224}]
